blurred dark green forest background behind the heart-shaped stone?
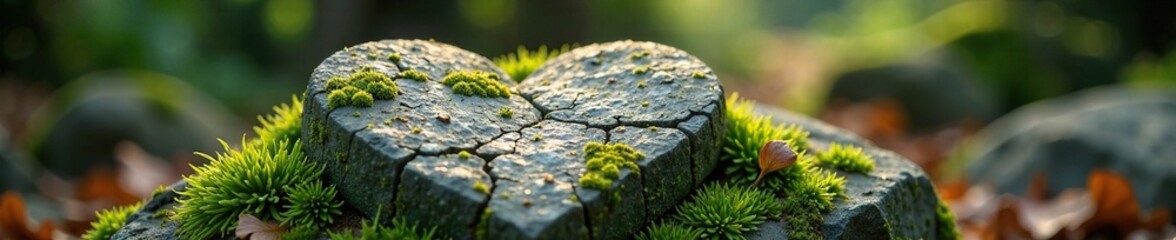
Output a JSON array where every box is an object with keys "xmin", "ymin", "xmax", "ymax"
[{"xmin": 0, "ymin": 0, "xmax": 1176, "ymax": 228}]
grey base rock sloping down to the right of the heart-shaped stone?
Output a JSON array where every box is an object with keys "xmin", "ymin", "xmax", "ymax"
[{"xmin": 746, "ymin": 105, "xmax": 938, "ymax": 239}]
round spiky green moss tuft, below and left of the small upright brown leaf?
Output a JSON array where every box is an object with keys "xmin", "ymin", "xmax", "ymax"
[{"xmin": 675, "ymin": 184, "xmax": 783, "ymax": 239}]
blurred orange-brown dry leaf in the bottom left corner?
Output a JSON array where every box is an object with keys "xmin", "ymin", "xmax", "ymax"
[{"xmin": 0, "ymin": 191, "xmax": 53, "ymax": 239}]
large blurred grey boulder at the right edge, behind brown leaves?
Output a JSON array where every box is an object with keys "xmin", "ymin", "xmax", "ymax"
[{"xmin": 967, "ymin": 85, "xmax": 1176, "ymax": 209}]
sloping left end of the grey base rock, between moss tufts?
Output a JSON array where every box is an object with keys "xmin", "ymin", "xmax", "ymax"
[{"xmin": 111, "ymin": 180, "xmax": 188, "ymax": 240}]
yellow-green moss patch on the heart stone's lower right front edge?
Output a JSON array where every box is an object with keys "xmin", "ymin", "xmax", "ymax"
[{"xmin": 580, "ymin": 141, "xmax": 646, "ymax": 191}]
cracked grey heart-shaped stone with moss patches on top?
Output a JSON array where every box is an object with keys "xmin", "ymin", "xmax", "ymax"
[{"xmin": 302, "ymin": 40, "xmax": 726, "ymax": 239}]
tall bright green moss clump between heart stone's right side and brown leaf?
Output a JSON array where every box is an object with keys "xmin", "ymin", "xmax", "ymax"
[{"xmin": 722, "ymin": 93, "xmax": 809, "ymax": 186}]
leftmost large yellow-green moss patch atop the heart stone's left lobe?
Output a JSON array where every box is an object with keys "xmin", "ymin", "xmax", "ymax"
[{"xmin": 327, "ymin": 67, "xmax": 400, "ymax": 109}]
